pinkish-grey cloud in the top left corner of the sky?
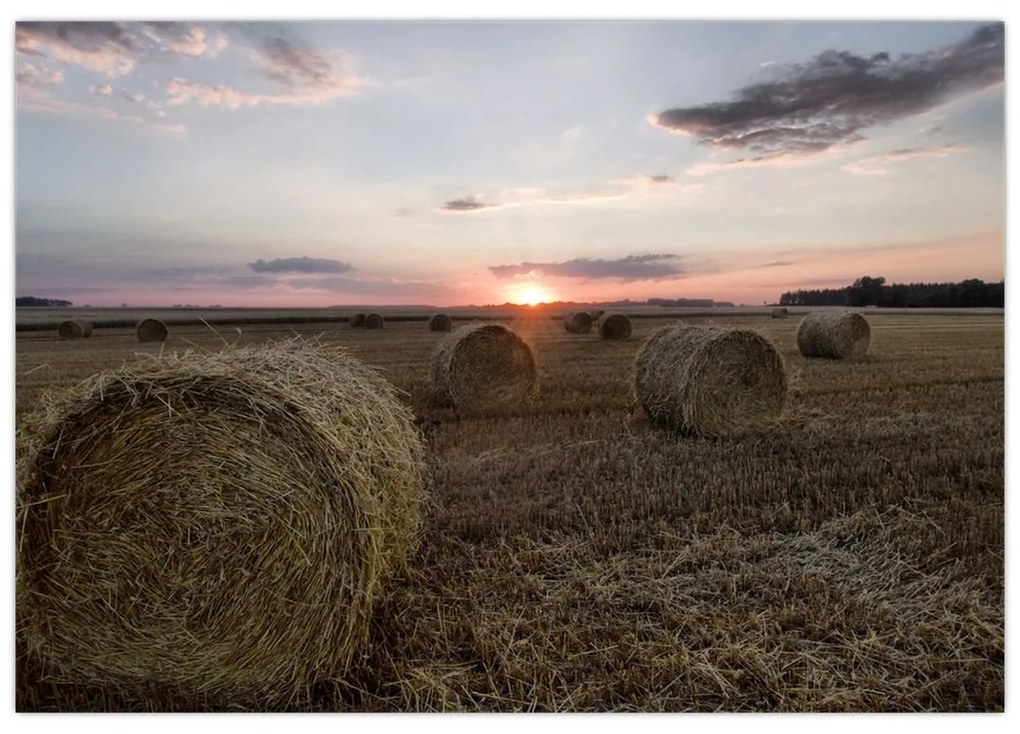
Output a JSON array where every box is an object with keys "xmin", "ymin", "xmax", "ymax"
[{"xmin": 14, "ymin": 20, "xmax": 142, "ymax": 76}]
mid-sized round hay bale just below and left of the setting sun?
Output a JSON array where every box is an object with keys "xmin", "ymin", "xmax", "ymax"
[{"xmin": 432, "ymin": 323, "xmax": 538, "ymax": 411}]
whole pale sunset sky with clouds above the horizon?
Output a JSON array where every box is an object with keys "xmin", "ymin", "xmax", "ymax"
[{"xmin": 10, "ymin": 14, "xmax": 1006, "ymax": 307}]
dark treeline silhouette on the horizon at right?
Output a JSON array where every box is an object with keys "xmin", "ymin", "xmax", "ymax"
[{"xmin": 779, "ymin": 275, "xmax": 1006, "ymax": 308}]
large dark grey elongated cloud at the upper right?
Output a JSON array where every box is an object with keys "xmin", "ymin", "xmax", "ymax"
[{"xmin": 650, "ymin": 23, "xmax": 1005, "ymax": 160}]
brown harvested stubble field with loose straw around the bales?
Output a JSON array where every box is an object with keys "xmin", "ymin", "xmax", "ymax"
[{"xmin": 15, "ymin": 312, "xmax": 1005, "ymax": 712}]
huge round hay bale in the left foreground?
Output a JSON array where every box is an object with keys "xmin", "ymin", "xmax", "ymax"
[{"xmin": 16, "ymin": 340, "xmax": 424, "ymax": 709}]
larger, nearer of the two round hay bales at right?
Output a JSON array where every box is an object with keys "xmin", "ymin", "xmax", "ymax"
[{"xmin": 634, "ymin": 324, "xmax": 786, "ymax": 436}]
